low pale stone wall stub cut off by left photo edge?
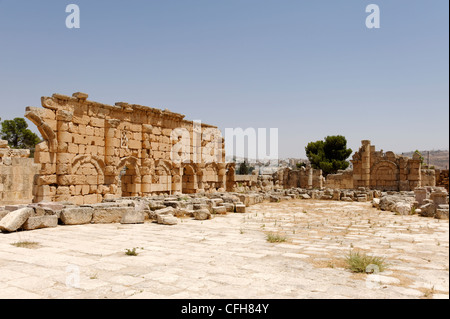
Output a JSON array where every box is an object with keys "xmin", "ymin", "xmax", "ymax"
[{"xmin": 0, "ymin": 140, "xmax": 39, "ymax": 205}]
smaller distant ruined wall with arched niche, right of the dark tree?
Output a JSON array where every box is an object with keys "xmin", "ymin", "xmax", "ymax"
[{"xmin": 326, "ymin": 140, "xmax": 436, "ymax": 191}]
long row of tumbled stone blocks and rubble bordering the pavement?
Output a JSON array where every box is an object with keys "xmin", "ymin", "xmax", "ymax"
[{"xmin": 0, "ymin": 187, "xmax": 449, "ymax": 232}]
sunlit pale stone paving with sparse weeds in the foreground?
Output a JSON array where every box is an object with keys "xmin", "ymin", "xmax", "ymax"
[{"xmin": 0, "ymin": 200, "xmax": 449, "ymax": 299}]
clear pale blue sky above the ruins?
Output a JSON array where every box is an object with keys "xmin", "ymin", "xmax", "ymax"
[{"xmin": 0, "ymin": 0, "xmax": 449, "ymax": 157}]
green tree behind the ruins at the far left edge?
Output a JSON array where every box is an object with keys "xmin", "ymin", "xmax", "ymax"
[{"xmin": 0, "ymin": 117, "xmax": 40, "ymax": 149}]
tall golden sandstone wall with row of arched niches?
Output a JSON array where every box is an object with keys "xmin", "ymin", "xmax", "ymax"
[{"xmin": 25, "ymin": 93, "xmax": 234, "ymax": 204}]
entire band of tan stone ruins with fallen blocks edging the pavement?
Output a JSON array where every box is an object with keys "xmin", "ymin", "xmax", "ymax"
[{"xmin": 0, "ymin": 92, "xmax": 448, "ymax": 232}]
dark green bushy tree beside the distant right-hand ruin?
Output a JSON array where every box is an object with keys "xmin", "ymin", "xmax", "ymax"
[{"xmin": 305, "ymin": 135, "xmax": 352, "ymax": 176}]
